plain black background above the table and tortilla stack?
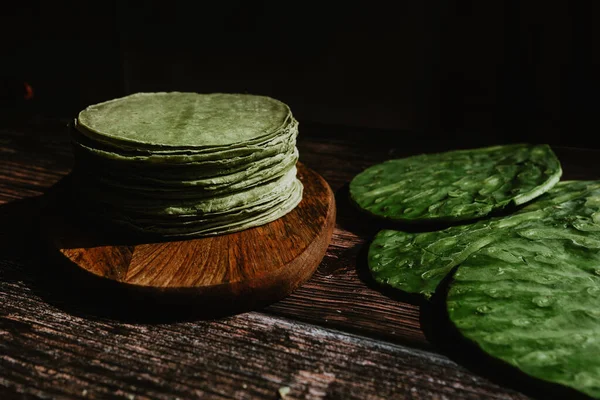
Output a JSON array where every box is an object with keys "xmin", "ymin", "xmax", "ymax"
[{"xmin": 0, "ymin": 0, "xmax": 600, "ymax": 147}]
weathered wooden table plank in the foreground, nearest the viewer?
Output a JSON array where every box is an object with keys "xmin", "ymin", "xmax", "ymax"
[{"xmin": 0, "ymin": 263, "xmax": 524, "ymax": 399}]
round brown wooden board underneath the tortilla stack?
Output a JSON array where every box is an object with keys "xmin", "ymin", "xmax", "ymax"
[{"xmin": 41, "ymin": 163, "xmax": 336, "ymax": 313}]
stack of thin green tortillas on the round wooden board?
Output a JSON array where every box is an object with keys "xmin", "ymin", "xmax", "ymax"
[{"xmin": 72, "ymin": 92, "xmax": 302, "ymax": 236}]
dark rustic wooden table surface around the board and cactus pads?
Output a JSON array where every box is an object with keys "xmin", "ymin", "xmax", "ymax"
[{"xmin": 0, "ymin": 117, "xmax": 600, "ymax": 399}]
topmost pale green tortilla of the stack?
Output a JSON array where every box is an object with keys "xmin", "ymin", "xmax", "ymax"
[{"xmin": 76, "ymin": 92, "xmax": 291, "ymax": 149}]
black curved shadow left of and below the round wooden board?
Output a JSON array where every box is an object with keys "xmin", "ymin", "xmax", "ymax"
[{"xmin": 0, "ymin": 178, "xmax": 266, "ymax": 323}]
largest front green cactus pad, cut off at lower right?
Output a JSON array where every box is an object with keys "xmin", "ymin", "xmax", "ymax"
[{"xmin": 447, "ymin": 182, "xmax": 600, "ymax": 398}]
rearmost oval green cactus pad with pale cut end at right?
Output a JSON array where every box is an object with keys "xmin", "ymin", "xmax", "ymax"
[{"xmin": 350, "ymin": 144, "xmax": 562, "ymax": 222}]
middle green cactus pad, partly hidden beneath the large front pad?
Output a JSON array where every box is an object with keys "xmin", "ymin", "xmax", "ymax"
[{"xmin": 368, "ymin": 181, "xmax": 600, "ymax": 298}]
